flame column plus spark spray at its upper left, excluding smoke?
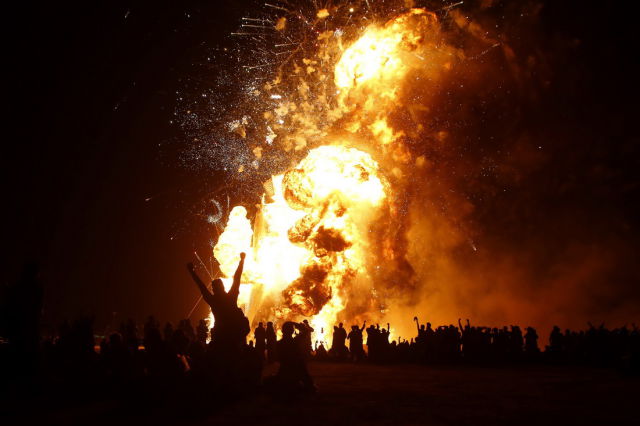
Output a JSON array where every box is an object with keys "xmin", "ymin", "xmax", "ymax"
[{"xmin": 181, "ymin": 2, "xmax": 496, "ymax": 340}]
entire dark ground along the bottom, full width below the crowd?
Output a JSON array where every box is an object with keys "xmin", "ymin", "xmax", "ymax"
[{"xmin": 0, "ymin": 363, "xmax": 640, "ymax": 426}]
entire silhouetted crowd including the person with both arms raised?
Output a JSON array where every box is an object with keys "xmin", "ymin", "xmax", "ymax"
[{"xmin": 0, "ymin": 254, "xmax": 640, "ymax": 406}]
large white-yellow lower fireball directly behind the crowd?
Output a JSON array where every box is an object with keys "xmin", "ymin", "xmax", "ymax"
[{"xmin": 214, "ymin": 146, "xmax": 388, "ymax": 340}]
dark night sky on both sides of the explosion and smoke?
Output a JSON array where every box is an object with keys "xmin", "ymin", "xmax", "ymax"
[{"xmin": 2, "ymin": 0, "xmax": 640, "ymax": 330}]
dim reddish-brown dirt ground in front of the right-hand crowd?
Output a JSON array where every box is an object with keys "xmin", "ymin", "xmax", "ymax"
[{"xmin": 208, "ymin": 363, "xmax": 640, "ymax": 425}]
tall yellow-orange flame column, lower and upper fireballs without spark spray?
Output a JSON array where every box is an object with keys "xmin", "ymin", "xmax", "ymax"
[{"xmin": 208, "ymin": 9, "xmax": 462, "ymax": 341}]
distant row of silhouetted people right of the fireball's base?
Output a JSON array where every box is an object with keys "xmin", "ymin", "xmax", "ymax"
[{"xmin": 315, "ymin": 318, "xmax": 640, "ymax": 371}]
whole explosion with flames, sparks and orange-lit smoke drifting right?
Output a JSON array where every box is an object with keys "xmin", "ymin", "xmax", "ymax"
[{"xmin": 175, "ymin": 0, "xmax": 640, "ymax": 339}]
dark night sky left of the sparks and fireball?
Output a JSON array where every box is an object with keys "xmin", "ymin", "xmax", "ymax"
[{"xmin": 3, "ymin": 1, "xmax": 251, "ymax": 328}]
